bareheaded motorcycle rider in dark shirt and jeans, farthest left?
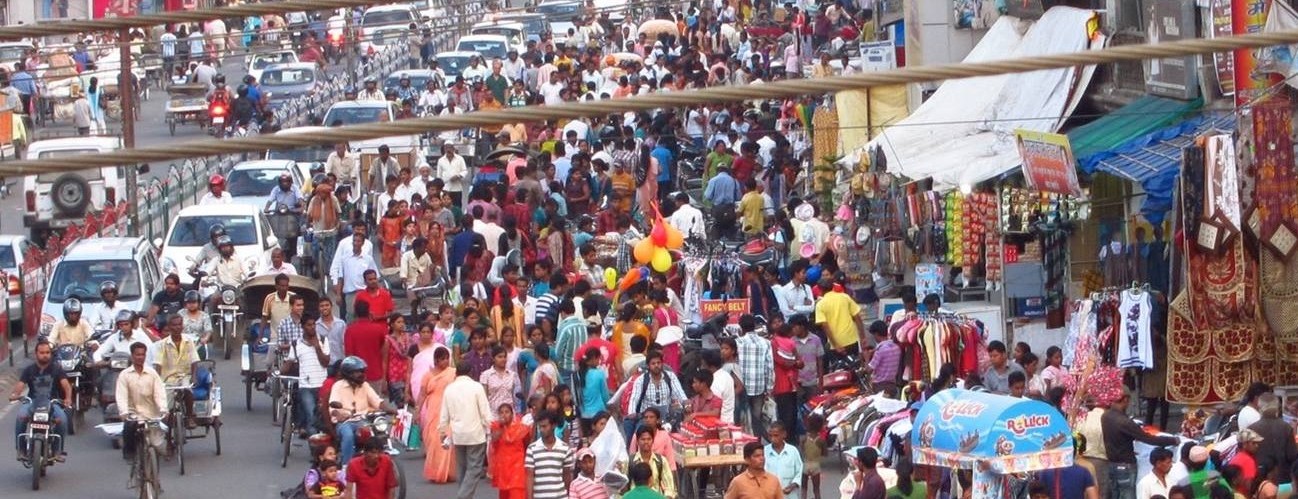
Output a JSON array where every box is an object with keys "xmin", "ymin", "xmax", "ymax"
[{"xmin": 9, "ymin": 340, "xmax": 73, "ymax": 461}]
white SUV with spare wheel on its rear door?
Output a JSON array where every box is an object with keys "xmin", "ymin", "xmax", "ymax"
[{"xmin": 22, "ymin": 136, "xmax": 148, "ymax": 246}]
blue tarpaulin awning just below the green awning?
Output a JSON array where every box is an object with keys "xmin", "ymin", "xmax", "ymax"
[{"xmin": 1081, "ymin": 113, "xmax": 1234, "ymax": 224}]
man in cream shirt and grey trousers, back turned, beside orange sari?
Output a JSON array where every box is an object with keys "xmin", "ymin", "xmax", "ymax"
[{"xmin": 430, "ymin": 363, "xmax": 493, "ymax": 499}]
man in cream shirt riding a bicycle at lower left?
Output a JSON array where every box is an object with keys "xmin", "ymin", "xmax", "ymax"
[{"xmin": 113, "ymin": 342, "xmax": 166, "ymax": 460}]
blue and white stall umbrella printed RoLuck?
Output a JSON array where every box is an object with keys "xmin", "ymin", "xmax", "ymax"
[{"xmin": 910, "ymin": 389, "xmax": 1073, "ymax": 499}]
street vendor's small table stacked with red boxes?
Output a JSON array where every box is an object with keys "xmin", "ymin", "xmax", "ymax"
[{"xmin": 671, "ymin": 420, "xmax": 757, "ymax": 499}]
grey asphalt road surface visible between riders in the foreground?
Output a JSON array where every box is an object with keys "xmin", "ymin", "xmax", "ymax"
[{"xmin": 0, "ymin": 355, "xmax": 842, "ymax": 499}]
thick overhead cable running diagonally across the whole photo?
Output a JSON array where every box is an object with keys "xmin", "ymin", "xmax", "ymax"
[{"xmin": 0, "ymin": 26, "xmax": 1298, "ymax": 175}]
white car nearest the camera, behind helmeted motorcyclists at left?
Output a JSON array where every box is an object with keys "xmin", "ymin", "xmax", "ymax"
[{"xmin": 40, "ymin": 238, "xmax": 164, "ymax": 334}]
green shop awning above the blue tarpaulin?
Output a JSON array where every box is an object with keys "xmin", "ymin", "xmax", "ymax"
[{"xmin": 1068, "ymin": 95, "xmax": 1203, "ymax": 165}]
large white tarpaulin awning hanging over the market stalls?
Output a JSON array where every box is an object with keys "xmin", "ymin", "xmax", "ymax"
[{"xmin": 857, "ymin": 6, "xmax": 1096, "ymax": 190}]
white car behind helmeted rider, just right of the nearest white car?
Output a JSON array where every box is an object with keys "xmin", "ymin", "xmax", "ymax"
[{"xmin": 154, "ymin": 204, "xmax": 279, "ymax": 286}]
